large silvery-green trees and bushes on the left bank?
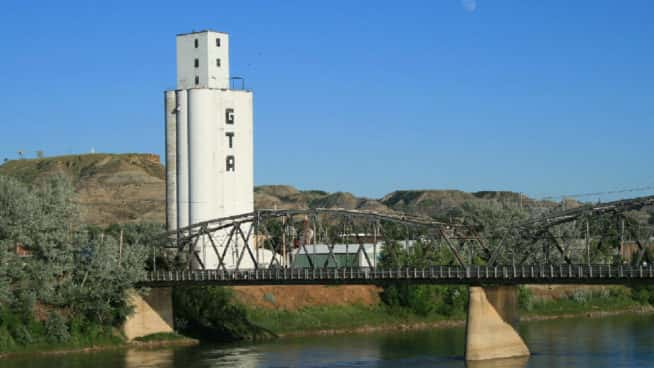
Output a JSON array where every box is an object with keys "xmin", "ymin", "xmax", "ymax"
[{"xmin": 0, "ymin": 176, "xmax": 147, "ymax": 352}]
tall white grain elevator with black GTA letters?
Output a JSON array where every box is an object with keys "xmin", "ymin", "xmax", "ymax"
[{"xmin": 165, "ymin": 31, "xmax": 270, "ymax": 268}]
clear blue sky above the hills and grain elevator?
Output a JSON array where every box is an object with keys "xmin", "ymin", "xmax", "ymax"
[{"xmin": 0, "ymin": 0, "xmax": 654, "ymax": 199}]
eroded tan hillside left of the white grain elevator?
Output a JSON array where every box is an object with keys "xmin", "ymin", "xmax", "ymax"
[{"xmin": 0, "ymin": 154, "xmax": 165, "ymax": 226}]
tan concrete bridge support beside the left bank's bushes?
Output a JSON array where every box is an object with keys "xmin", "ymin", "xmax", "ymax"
[{"xmin": 123, "ymin": 288, "xmax": 173, "ymax": 340}]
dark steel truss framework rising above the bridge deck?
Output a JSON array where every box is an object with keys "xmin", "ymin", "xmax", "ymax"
[{"xmin": 153, "ymin": 196, "xmax": 654, "ymax": 272}]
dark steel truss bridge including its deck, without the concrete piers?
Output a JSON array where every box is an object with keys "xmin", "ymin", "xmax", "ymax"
[{"xmin": 143, "ymin": 196, "xmax": 654, "ymax": 286}]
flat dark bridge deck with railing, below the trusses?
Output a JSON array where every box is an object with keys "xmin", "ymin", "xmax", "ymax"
[{"xmin": 139, "ymin": 264, "xmax": 654, "ymax": 287}]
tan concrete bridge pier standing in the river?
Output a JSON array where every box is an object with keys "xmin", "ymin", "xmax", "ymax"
[{"xmin": 466, "ymin": 286, "xmax": 529, "ymax": 361}]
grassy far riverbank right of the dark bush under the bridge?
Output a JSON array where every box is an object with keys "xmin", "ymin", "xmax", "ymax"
[{"xmin": 243, "ymin": 287, "xmax": 654, "ymax": 337}]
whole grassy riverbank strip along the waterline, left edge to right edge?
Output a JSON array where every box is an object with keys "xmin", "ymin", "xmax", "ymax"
[{"xmin": 0, "ymin": 287, "xmax": 654, "ymax": 357}]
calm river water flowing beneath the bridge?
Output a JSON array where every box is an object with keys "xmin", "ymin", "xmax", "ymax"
[{"xmin": 0, "ymin": 315, "xmax": 654, "ymax": 368}]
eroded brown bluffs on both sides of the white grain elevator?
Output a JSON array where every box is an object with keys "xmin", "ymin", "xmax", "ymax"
[{"xmin": 0, "ymin": 154, "xmax": 596, "ymax": 226}]
